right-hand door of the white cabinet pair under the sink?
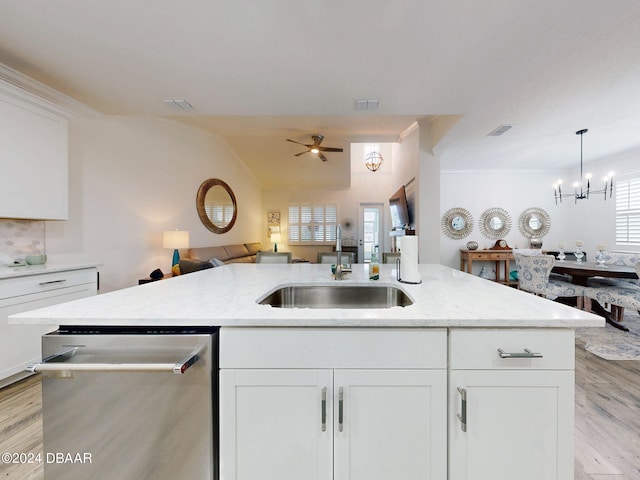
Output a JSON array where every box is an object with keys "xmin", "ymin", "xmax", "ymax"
[{"xmin": 333, "ymin": 369, "xmax": 447, "ymax": 480}]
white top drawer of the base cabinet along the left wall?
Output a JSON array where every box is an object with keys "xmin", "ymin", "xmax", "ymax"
[{"xmin": 0, "ymin": 268, "xmax": 97, "ymax": 300}]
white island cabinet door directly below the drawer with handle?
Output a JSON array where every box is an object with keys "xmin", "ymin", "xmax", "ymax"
[{"xmin": 449, "ymin": 370, "xmax": 574, "ymax": 480}]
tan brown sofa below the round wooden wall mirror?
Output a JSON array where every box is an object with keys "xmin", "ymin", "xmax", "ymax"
[{"xmin": 180, "ymin": 242, "xmax": 262, "ymax": 274}]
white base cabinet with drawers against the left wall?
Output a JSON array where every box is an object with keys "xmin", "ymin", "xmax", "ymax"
[{"xmin": 0, "ymin": 268, "xmax": 97, "ymax": 384}]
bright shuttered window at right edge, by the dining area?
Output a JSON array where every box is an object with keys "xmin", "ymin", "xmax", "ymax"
[{"xmin": 616, "ymin": 177, "xmax": 640, "ymax": 246}]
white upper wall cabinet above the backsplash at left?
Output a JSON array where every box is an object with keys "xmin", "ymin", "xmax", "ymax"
[{"xmin": 0, "ymin": 84, "xmax": 68, "ymax": 220}]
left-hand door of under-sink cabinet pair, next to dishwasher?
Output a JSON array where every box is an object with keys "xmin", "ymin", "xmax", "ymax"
[{"xmin": 220, "ymin": 369, "xmax": 333, "ymax": 480}]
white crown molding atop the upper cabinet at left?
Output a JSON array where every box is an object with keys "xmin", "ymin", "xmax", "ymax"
[{"xmin": 0, "ymin": 63, "xmax": 102, "ymax": 118}]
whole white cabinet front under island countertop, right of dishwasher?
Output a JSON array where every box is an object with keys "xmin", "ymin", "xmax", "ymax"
[{"xmin": 220, "ymin": 328, "xmax": 575, "ymax": 480}]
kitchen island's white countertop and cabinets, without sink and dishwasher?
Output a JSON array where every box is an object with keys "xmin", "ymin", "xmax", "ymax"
[{"xmin": 10, "ymin": 264, "xmax": 604, "ymax": 480}]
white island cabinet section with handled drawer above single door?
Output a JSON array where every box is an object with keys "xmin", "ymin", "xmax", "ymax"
[{"xmin": 449, "ymin": 329, "xmax": 574, "ymax": 480}]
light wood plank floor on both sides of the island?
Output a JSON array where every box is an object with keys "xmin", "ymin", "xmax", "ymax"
[{"xmin": 0, "ymin": 340, "xmax": 640, "ymax": 480}]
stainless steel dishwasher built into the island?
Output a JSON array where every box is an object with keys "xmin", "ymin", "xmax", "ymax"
[{"xmin": 29, "ymin": 326, "xmax": 218, "ymax": 480}]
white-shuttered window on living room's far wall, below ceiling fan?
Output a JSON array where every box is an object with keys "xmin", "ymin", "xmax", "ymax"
[{"xmin": 289, "ymin": 204, "xmax": 338, "ymax": 245}]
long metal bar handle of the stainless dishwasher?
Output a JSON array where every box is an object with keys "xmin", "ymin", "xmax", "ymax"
[{"xmin": 27, "ymin": 348, "xmax": 200, "ymax": 375}]
